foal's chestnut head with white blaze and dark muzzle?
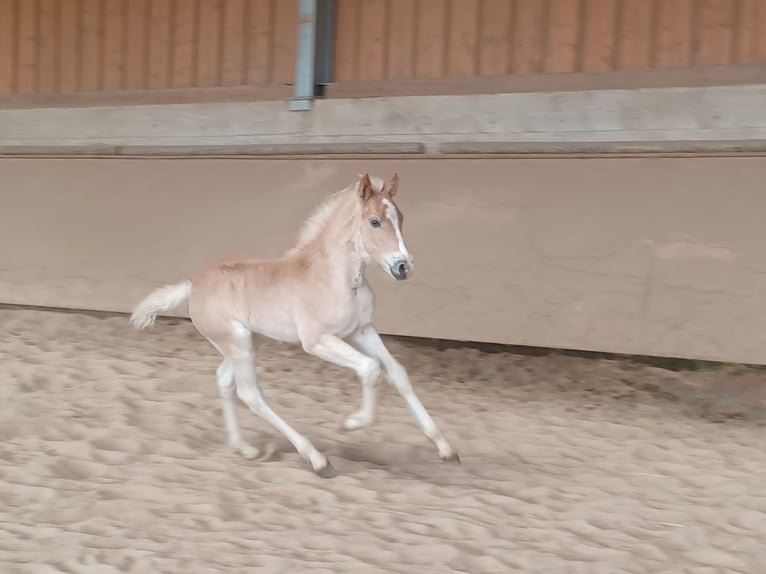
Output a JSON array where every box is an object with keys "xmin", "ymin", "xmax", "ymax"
[{"xmin": 357, "ymin": 174, "xmax": 415, "ymax": 281}]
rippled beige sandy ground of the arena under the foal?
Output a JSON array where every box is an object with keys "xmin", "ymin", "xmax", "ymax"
[{"xmin": 0, "ymin": 309, "xmax": 766, "ymax": 574}]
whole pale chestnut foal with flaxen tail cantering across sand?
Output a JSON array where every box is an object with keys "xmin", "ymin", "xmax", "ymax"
[{"xmin": 130, "ymin": 174, "xmax": 459, "ymax": 477}]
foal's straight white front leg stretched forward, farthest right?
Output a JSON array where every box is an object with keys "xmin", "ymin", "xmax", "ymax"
[{"xmin": 351, "ymin": 323, "xmax": 460, "ymax": 462}]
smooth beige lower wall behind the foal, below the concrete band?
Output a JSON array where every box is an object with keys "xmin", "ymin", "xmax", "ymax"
[{"xmin": 0, "ymin": 157, "xmax": 766, "ymax": 363}]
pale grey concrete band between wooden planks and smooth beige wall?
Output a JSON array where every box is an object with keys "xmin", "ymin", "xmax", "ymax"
[{"xmin": 0, "ymin": 80, "xmax": 766, "ymax": 153}]
